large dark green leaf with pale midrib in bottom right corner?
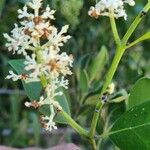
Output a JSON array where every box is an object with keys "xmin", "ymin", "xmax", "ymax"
[{"xmin": 108, "ymin": 101, "xmax": 150, "ymax": 150}]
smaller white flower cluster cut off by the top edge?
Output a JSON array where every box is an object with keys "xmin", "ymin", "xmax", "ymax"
[{"xmin": 88, "ymin": 0, "xmax": 135, "ymax": 20}]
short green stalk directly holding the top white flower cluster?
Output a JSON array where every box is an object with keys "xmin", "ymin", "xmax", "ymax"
[{"xmin": 109, "ymin": 16, "xmax": 120, "ymax": 45}]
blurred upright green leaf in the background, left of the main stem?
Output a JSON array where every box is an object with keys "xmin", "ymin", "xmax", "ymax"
[{"xmin": 88, "ymin": 46, "xmax": 109, "ymax": 82}]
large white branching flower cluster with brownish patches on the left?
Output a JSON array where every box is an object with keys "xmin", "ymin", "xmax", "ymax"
[{"xmin": 4, "ymin": 0, "xmax": 73, "ymax": 131}]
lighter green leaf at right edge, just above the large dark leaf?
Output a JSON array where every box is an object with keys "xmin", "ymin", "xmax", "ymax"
[{"xmin": 128, "ymin": 78, "xmax": 150, "ymax": 108}]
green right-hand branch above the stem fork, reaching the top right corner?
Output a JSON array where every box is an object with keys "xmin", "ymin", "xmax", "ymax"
[{"xmin": 122, "ymin": 1, "xmax": 150, "ymax": 44}]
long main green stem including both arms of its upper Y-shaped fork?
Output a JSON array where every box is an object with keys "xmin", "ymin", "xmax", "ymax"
[{"xmin": 89, "ymin": 2, "xmax": 150, "ymax": 138}]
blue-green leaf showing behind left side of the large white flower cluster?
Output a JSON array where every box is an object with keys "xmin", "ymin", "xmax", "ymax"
[{"xmin": 9, "ymin": 59, "xmax": 42, "ymax": 101}]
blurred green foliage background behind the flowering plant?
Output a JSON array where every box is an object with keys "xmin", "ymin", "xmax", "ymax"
[{"xmin": 0, "ymin": 0, "xmax": 150, "ymax": 150}]
